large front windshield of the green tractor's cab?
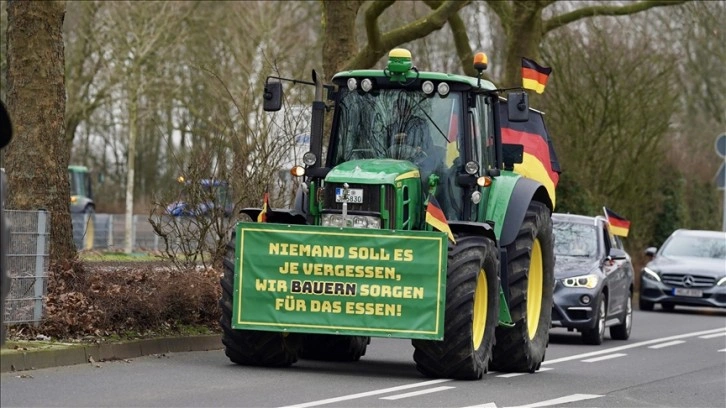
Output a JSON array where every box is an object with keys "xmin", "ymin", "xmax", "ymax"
[{"xmin": 332, "ymin": 89, "xmax": 462, "ymax": 177}]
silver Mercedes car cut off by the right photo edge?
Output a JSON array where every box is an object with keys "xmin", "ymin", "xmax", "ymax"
[{"xmin": 639, "ymin": 229, "xmax": 726, "ymax": 311}]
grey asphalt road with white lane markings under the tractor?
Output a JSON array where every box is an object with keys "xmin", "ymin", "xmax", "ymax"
[{"xmin": 0, "ymin": 308, "xmax": 726, "ymax": 408}]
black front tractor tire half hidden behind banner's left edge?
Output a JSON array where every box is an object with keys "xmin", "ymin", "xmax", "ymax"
[{"xmin": 219, "ymin": 233, "xmax": 303, "ymax": 367}]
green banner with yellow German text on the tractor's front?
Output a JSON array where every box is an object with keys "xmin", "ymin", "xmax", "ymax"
[{"xmin": 232, "ymin": 222, "xmax": 448, "ymax": 340}]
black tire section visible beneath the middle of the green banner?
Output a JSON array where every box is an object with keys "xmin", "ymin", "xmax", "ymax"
[{"xmin": 300, "ymin": 334, "xmax": 371, "ymax": 361}]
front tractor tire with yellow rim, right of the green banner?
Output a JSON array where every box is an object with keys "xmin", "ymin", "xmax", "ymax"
[{"xmin": 412, "ymin": 235, "xmax": 499, "ymax": 380}]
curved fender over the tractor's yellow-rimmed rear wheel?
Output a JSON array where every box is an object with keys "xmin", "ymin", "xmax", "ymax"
[{"xmin": 499, "ymin": 177, "xmax": 553, "ymax": 248}]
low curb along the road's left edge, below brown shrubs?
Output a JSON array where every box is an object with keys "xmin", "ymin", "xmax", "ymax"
[{"xmin": 0, "ymin": 334, "xmax": 223, "ymax": 373}]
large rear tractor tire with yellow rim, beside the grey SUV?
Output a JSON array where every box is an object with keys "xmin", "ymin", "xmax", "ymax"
[{"xmin": 490, "ymin": 201, "xmax": 555, "ymax": 373}]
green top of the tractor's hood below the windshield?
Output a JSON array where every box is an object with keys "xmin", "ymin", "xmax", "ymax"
[{"xmin": 325, "ymin": 159, "xmax": 421, "ymax": 184}]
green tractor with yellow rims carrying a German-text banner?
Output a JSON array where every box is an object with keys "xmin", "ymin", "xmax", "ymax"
[{"xmin": 220, "ymin": 49, "xmax": 559, "ymax": 379}]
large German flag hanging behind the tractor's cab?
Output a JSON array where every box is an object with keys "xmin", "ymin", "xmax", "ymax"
[{"xmin": 499, "ymin": 103, "xmax": 561, "ymax": 205}]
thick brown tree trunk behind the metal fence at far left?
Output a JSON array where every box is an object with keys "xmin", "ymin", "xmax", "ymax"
[{"xmin": 5, "ymin": 1, "xmax": 77, "ymax": 262}]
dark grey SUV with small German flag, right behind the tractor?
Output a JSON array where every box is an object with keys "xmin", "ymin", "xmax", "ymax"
[{"xmin": 552, "ymin": 213, "xmax": 634, "ymax": 344}]
